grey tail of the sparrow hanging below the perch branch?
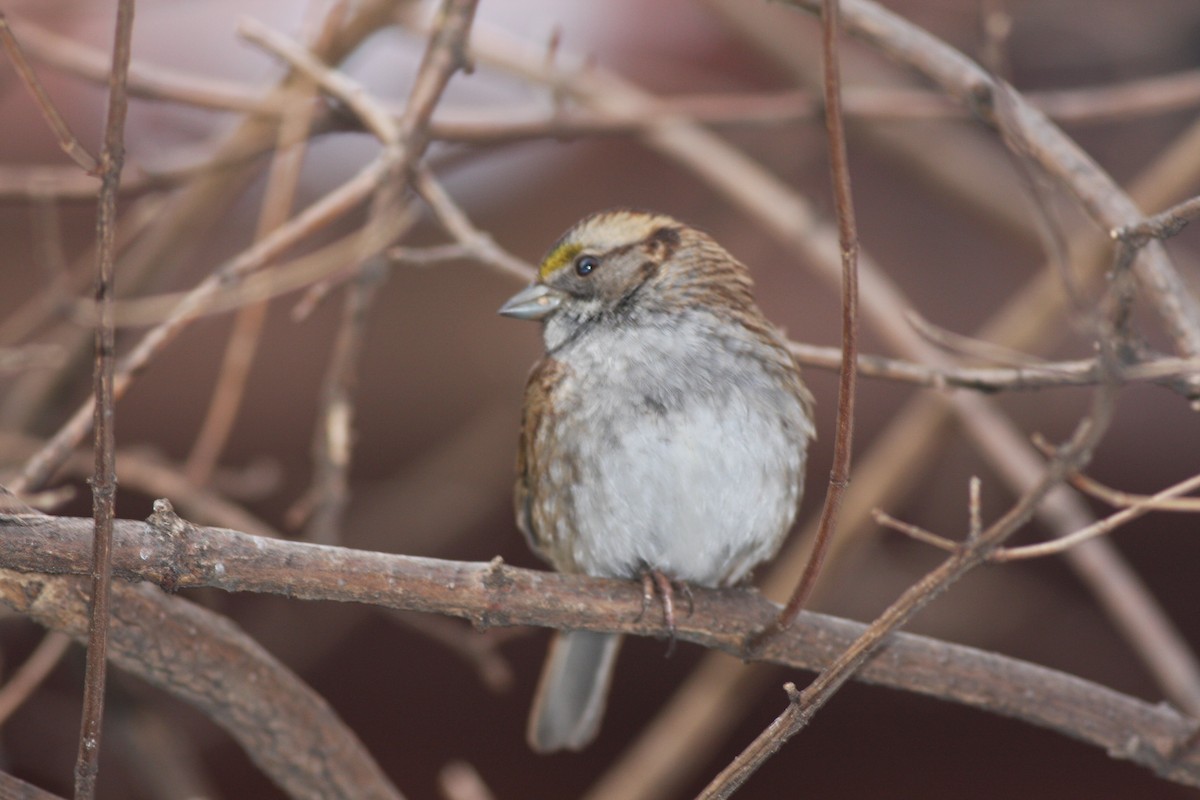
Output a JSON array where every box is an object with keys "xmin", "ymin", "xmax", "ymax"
[{"xmin": 527, "ymin": 631, "xmax": 622, "ymax": 753}]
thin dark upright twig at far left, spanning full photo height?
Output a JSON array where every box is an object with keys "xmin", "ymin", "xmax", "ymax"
[{"xmin": 74, "ymin": 0, "xmax": 134, "ymax": 800}]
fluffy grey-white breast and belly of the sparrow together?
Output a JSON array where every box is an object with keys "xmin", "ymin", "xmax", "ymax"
[{"xmin": 547, "ymin": 316, "xmax": 812, "ymax": 585}]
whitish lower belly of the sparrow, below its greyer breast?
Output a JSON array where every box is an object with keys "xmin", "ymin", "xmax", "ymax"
[{"xmin": 561, "ymin": 396, "xmax": 808, "ymax": 585}]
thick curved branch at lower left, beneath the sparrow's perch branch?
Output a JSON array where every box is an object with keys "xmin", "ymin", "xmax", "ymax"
[{"xmin": 0, "ymin": 563, "xmax": 400, "ymax": 800}]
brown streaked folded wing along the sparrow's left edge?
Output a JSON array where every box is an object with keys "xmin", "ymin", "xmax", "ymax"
[{"xmin": 512, "ymin": 357, "xmax": 566, "ymax": 564}]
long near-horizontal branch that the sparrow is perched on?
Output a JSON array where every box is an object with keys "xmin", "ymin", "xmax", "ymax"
[{"xmin": 0, "ymin": 501, "xmax": 1200, "ymax": 786}]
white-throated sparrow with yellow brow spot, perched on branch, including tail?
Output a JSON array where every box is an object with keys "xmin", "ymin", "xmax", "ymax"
[{"xmin": 500, "ymin": 210, "xmax": 814, "ymax": 752}]
